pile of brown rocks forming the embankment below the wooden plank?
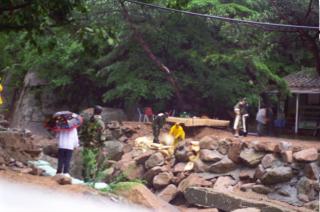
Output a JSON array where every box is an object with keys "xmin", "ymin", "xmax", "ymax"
[{"xmin": 109, "ymin": 136, "xmax": 320, "ymax": 211}]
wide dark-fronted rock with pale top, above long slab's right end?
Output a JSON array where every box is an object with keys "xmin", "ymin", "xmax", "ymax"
[{"xmin": 259, "ymin": 166, "xmax": 292, "ymax": 185}]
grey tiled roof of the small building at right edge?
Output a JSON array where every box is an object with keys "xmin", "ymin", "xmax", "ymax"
[{"xmin": 284, "ymin": 71, "xmax": 320, "ymax": 93}]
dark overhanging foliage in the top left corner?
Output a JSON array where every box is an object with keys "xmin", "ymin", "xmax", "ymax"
[{"xmin": 0, "ymin": 0, "xmax": 85, "ymax": 31}]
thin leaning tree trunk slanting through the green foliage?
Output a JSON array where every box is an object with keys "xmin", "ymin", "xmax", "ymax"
[{"xmin": 119, "ymin": 0, "xmax": 184, "ymax": 109}]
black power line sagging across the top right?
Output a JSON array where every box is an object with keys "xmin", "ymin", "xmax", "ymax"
[{"xmin": 124, "ymin": 0, "xmax": 320, "ymax": 31}]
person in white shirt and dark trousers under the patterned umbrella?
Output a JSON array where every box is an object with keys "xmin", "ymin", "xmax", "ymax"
[{"xmin": 57, "ymin": 128, "xmax": 79, "ymax": 177}]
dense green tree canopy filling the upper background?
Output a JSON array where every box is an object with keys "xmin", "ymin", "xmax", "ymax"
[{"xmin": 0, "ymin": 0, "xmax": 320, "ymax": 117}]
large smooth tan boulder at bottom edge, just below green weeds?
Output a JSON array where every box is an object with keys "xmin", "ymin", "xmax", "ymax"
[{"xmin": 115, "ymin": 183, "xmax": 178, "ymax": 212}]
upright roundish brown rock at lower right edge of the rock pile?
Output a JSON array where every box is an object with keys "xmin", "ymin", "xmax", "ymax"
[{"xmin": 297, "ymin": 177, "xmax": 317, "ymax": 202}]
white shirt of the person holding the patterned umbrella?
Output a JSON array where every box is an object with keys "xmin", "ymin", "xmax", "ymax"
[{"xmin": 57, "ymin": 128, "xmax": 79, "ymax": 150}]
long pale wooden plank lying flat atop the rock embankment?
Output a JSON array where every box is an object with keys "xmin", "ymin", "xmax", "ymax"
[{"xmin": 166, "ymin": 116, "xmax": 230, "ymax": 127}]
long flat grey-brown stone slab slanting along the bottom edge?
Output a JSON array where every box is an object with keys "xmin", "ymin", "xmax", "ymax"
[{"xmin": 184, "ymin": 187, "xmax": 290, "ymax": 212}]
